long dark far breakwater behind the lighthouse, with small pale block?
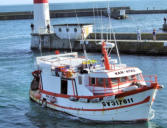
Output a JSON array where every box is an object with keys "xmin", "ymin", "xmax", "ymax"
[{"xmin": 0, "ymin": 7, "xmax": 167, "ymax": 20}]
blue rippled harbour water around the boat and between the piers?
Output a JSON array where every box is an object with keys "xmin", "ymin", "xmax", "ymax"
[{"xmin": 0, "ymin": 0, "xmax": 167, "ymax": 128}]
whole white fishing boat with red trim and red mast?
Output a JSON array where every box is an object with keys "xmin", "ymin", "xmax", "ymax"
[{"xmin": 30, "ymin": 41, "xmax": 162, "ymax": 122}]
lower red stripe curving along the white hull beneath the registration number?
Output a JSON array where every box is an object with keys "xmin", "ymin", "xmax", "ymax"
[{"xmin": 47, "ymin": 96, "xmax": 150, "ymax": 111}]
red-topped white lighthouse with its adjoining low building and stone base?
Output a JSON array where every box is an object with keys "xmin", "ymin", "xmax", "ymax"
[{"xmin": 30, "ymin": 0, "xmax": 93, "ymax": 51}]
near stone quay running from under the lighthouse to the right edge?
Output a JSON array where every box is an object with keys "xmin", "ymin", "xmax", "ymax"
[{"xmin": 31, "ymin": 33, "xmax": 167, "ymax": 55}]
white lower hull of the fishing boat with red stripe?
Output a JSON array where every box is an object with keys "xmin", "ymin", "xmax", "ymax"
[{"xmin": 30, "ymin": 88, "xmax": 157, "ymax": 122}]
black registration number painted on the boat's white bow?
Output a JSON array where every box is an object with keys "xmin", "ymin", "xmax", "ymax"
[{"xmin": 102, "ymin": 98, "xmax": 134, "ymax": 107}]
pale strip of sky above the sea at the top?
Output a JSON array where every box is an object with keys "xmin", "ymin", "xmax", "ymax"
[{"xmin": 0, "ymin": 0, "xmax": 106, "ymax": 5}]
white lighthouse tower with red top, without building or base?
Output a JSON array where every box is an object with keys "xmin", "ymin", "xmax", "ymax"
[{"xmin": 34, "ymin": 0, "xmax": 50, "ymax": 33}]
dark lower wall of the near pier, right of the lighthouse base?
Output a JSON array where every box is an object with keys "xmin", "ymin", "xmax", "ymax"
[{"xmin": 82, "ymin": 40, "xmax": 167, "ymax": 55}]
